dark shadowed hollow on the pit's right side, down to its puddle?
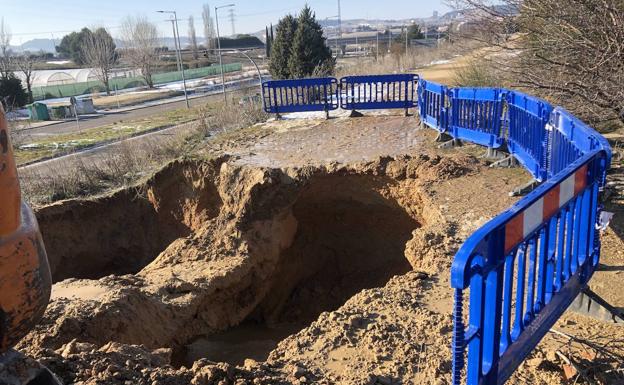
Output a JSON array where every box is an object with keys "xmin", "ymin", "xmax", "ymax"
[{"xmin": 176, "ymin": 175, "xmax": 419, "ymax": 366}]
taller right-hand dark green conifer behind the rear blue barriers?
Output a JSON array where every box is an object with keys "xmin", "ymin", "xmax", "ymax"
[{"xmin": 288, "ymin": 5, "xmax": 335, "ymax": 78}]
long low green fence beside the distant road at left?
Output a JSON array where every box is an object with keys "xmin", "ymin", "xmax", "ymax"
[{"xmin": 32, "ymin": 63, "xmax": 243, "ymax": 100}]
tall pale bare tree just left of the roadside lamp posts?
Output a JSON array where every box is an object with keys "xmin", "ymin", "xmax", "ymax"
[{"xmin": 121, "ymin": 16, "xmax": 159, "ymax": 88}]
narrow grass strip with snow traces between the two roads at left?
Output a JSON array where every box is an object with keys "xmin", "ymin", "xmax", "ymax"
[{"xmin": 15, "ymin": 108, "xmax": 210, "ymax": 165}]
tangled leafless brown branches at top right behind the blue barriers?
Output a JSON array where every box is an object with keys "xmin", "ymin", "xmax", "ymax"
[{"xmin": 460, "ymin": 0, "xmax": 624, "ymax": 124}]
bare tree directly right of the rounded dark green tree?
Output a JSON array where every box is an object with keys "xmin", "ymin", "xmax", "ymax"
[{"xmin": 81, "ymin": 28, "xmax": 117, "ymax": 95}]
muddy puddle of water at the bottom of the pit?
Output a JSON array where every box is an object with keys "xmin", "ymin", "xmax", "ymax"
[{"xmin": 179, "ymin": 322, "xmax": 306, "ymax": 367}]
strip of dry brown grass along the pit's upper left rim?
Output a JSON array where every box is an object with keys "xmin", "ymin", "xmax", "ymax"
[{"xmin": 21, "ymin": 95, "xmax": 266, "ymax": 206}]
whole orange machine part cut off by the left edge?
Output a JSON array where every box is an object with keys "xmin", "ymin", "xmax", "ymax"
[{"xmin": 0, "ymin": 105, "xmax": 52, "ymax": 355}]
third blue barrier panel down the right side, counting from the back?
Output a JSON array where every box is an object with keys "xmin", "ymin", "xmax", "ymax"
[{"xmin": 506, "ymin": 91, "xmax": 552, "ymax": 181}]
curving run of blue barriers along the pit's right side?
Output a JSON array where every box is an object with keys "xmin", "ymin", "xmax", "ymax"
[{"xmin": 265, "ymin": 75, "xmax": 611, "ymax": 385}]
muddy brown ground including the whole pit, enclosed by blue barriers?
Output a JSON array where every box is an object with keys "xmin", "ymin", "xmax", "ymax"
[{"xmin": 11, "ymin": 112, "xmax": 624, "ymax": 385}]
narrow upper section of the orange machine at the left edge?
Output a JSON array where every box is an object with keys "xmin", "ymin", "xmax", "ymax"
[{"xmin": 0, "ymin": 104, "xmax": 21, "ymax": 237}]
